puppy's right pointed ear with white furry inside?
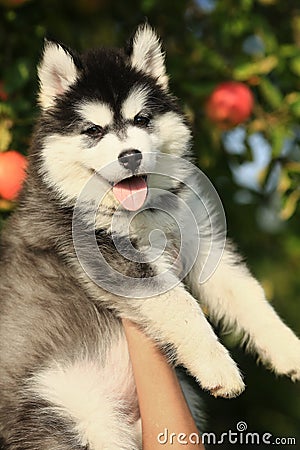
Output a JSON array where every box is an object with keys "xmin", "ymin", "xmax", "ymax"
[{"xmin": 130, "ymin": 24, "xmax": 168, "ymax": 89}]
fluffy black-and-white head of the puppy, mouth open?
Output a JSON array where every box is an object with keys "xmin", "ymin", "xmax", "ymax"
[{"xmin": 34, "ymin": 25, "xmax": 190, "ymax": 211}]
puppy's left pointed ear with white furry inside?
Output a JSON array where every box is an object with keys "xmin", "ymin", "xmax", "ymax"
[{"xmin": 38, "ymin": 41, "xmax": 79, "ymax": 109}]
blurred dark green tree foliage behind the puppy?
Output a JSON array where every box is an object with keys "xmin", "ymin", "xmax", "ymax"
[{"xmin": 0, "ymin": 0, "xmax": 300, "ymax": 442}]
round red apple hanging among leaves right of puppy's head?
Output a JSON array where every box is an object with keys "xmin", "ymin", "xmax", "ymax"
[{"xmin": 205, "ymin": 81, "xmax": 254, "ymax": 128}]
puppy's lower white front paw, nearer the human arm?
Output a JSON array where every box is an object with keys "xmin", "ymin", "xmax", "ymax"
[{"xmin": 191, "ymin": 344, "xmax": 245, "ymax": 398}]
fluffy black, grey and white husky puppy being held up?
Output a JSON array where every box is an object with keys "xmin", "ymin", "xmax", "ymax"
[{"xmin": 0, "ymin": 25, "xmax": 300, "ymax": 450}]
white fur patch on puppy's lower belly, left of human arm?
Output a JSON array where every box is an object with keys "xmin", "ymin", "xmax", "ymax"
[{"xmin": 23, "ymin": 338, "xmax": 140, "ymax": 450}]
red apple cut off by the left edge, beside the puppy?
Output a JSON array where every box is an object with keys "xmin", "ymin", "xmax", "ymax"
[{"xmin": 0, "ymin": 150, "xmax": 27, "ymax": 200}]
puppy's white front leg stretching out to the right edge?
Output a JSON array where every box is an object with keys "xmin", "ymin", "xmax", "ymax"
[{"xmin": 188, "ymin": 250, "xmax": 300, "ymax": 380}]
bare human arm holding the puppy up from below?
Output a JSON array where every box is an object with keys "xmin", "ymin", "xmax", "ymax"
[{"xmin": 123, "ymin": 319, "xmax": 204, "ymax": 450}]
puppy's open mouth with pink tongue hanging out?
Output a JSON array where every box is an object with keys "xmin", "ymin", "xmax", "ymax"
[{"xmin": 113, "ymin": 177, "xmax": 148, "ymax": 211}]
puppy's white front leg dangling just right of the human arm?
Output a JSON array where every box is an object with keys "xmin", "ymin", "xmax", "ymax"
[{"xmin": 123, "ymin": 285, "xmax": 244, "ymax": 397}]
